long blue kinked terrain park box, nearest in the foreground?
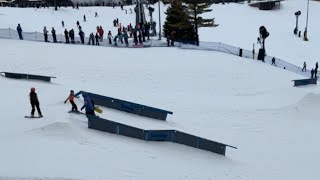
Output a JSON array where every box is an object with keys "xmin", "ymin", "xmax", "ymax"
[{"xmin": 87, "ymin": 115, "xmax": 237, "ymax": 156}]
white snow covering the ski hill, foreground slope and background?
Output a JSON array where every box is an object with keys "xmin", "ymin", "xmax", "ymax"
[{"xmin": 0, "ymin": 1, "xmax": 320, "ymax": 180}]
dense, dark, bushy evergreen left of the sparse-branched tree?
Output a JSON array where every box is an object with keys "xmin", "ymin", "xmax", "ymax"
[{"xmin": 163, "ymin": 0, "xmax": 196, "ymax": 43}]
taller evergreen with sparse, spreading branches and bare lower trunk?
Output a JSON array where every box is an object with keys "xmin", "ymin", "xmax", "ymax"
[{"xmin": 183, "ymin": 0, "xmax": 218, "ymax": 46}]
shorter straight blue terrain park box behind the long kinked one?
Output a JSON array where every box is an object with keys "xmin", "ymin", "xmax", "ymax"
[{"xmin": 75, "ymin": 91, "xmax": 173, "ymax": 121}]
